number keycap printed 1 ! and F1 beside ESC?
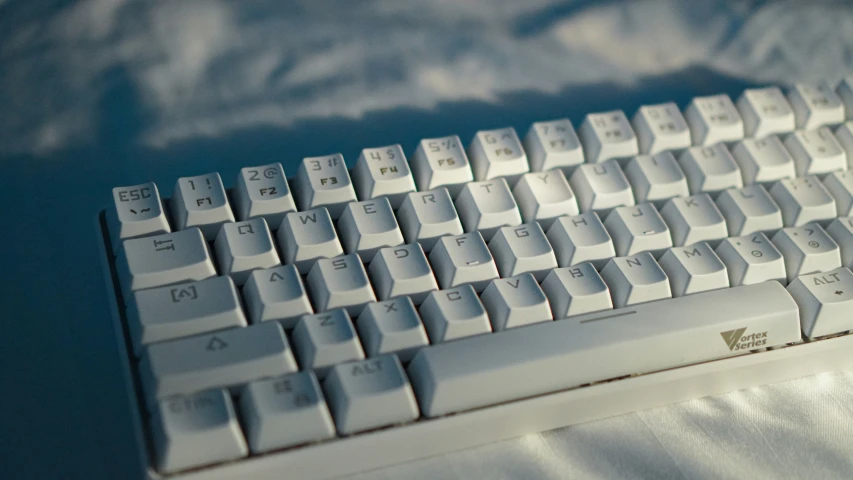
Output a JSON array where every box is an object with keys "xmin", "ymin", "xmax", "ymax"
[{"xmin": 170, "ymin": 173, "xmax": 234, "ymax": 241}]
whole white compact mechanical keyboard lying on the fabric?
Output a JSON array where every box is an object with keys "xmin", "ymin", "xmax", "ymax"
[{"xmin": 97, "ymin": 77, "xmax": 853, "ymax": 479}]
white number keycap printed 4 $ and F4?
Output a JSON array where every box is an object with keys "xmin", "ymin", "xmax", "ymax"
[{"xmin": 352, "ymin": 144, "xmax": 415, "ymax": 210}]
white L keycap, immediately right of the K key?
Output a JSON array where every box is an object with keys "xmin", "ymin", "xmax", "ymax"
[{"xmin": 717, "ymin": 185, "xmax": 784, "ymax": 237}]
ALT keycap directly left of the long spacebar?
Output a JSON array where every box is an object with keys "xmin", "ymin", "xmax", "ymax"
[{"xmin": 323, "ymin": 355, "xmax": 420, "ymax": 435}]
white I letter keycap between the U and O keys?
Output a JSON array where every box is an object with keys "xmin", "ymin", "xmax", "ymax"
[{"xmin": 625, "ymin": 152, "xmax": 690, "ymax": 207}]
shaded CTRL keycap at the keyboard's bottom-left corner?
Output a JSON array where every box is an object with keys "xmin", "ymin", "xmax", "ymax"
[{"xmin": 151, "ymin": 389, "xmax": 249, "ymax": 474}]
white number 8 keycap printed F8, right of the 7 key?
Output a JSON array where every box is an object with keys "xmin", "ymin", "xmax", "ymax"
[{"xmin": 578, "ymin": 110, "xmax": 640, "ymax": 163}]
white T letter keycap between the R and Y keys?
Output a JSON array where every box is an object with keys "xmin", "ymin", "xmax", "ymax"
[{"xmin": 456, "ymin": 178, "xmax": 521, "ymax": 241}]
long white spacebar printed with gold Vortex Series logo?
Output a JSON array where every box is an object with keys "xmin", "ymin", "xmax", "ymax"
[{"xmin": 408, "ymin": 282, "xmax": 800, "ymax": 417}]
